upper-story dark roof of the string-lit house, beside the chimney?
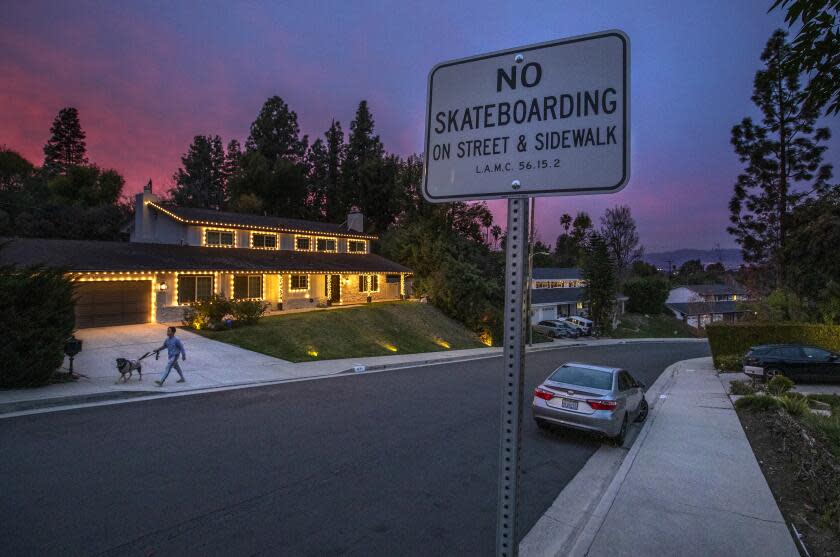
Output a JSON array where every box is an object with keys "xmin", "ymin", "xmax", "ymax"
[{"xmin": 148, "ymin": 202, "xmax": 377, "ymax": 239}]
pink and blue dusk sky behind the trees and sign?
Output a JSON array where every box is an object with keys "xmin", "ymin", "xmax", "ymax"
[{"xmin": 0, "ymin": 0, "xmax": 840, "ymax": 252}]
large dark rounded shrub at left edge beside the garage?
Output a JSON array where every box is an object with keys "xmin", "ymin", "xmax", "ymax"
[{"xmin": 0, "ymin": 266, "xmax": 76, "ymax": 388}]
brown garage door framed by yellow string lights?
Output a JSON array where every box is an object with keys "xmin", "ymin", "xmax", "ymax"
[{"xmin": 76, "ymin": 280, "xmax": 152, "ymax": 329}]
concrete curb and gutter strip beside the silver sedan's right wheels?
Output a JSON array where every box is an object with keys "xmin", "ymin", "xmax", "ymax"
[{"xmin": 520, "ymin": 360, "xmax": 690, "ymax": 557}]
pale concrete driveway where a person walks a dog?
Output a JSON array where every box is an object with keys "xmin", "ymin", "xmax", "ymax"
[{"xmin": 0, "ymin": 323, "xmax": 306, "ymax": 403}]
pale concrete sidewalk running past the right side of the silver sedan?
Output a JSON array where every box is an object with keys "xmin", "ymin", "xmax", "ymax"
[{"xmin": 564, "ymin": 358, "xmax": 799, "ymax": 557}]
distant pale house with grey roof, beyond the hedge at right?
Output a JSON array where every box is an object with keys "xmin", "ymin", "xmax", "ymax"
[{"xmin": 665, "ymin": 284, "xmax": 748, "ymax": 328}]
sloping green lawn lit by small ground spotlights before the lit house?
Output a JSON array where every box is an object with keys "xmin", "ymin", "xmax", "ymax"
[{"xmin": 195, "ymin": 302, "xmax": 484, "ymax": 362}]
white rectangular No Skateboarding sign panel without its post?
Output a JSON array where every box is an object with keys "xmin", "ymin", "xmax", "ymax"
[{"xmin": 423, "ymin": 31, "xmax": 630, "ymax": 202}]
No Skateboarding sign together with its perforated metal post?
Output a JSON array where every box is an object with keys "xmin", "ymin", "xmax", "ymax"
[{"xmin": 423, "ymin": 31, "xmax": 630, "ymax": 557}]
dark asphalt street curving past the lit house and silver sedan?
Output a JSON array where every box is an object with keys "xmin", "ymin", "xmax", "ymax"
[{"xmin": 0, "ymin": 343, "xmax": 708, "ymax": 556}]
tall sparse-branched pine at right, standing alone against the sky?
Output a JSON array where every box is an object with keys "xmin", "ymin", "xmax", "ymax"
[{"xmin": 727, "ymin": 30, "xmax": 831, "ymax": 287}]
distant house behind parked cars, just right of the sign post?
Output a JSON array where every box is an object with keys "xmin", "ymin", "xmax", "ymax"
[{"xmin": 531, "ymin": 267, "xmax": 627, "ymax": 323}]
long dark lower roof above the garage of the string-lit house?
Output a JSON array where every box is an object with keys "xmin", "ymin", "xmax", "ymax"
[{"xmin": 0, "ymin": 238, "xmax": 411, "ymax": 273}]
